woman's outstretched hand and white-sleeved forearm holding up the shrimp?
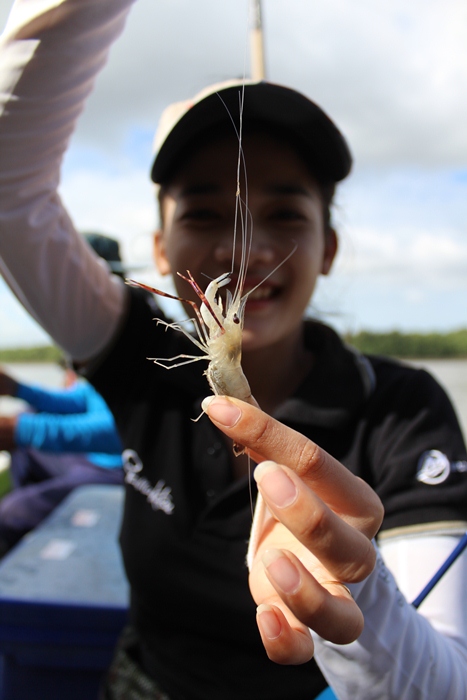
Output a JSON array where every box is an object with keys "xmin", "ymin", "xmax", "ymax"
[{"xmin": 204, "ymin": 397, "xmax": 467, "ymax": 700}]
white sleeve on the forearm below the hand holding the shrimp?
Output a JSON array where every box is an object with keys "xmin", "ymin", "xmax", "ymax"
[{"xmin": 313, "ymin": 534, "xmax": 467, "ymax": 700}]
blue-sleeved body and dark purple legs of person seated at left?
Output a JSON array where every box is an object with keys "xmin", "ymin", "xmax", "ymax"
[{"xmin": 0, "ymin": 369, "xmax": 123, "ymax": 553}]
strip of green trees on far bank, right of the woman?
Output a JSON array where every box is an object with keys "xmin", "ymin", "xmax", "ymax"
[{"xmin": 345, "ymin": 329, "xmax": 467, "ymax": 359}]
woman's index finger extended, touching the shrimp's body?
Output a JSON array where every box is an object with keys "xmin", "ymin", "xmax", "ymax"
[{"xmin": 203, "ymin": 396, "xmax": 382, "ymax": 537}]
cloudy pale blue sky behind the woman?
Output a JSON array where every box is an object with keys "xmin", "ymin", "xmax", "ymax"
[{"xmin": 0, "ymin": 0, "xmax": 467, "ymax": 347}]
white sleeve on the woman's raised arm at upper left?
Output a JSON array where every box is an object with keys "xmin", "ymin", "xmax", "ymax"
[{"xmin": 0, "ymin": 0, "xmax": 133, "ymax": 360}]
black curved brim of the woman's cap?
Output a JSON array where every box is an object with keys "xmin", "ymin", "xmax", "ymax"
[{"xmin": 151, "ymin": 82, "xmax": 352, "ymax": 184}]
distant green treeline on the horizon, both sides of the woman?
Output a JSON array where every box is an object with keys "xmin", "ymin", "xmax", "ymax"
[{"xmin": 0, "ymin": 328, "xmax": 467, "ymax": 363}]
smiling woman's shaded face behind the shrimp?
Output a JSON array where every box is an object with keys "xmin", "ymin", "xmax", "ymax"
[{"xmin": 155, "ymin": 133, "xmax": 337, "ymax": 352}]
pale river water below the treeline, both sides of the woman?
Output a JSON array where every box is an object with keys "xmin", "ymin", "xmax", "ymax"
[{"xmin": 0, "ymin": 360, "xmax": 467, "ymax": 438}]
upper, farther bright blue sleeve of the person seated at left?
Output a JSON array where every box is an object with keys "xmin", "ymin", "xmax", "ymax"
[{"xmin": 16, "ymin": 382, "xmax": 87, "ymax": 413}]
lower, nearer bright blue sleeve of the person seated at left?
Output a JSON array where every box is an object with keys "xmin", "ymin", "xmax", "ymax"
[{"xmin": 15, "ymin": 382, "xmax": 122, "ymax": 454}]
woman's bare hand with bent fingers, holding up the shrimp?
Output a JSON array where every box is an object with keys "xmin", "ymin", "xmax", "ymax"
[{"xmin": 203, "ymin": 396, "xmax": 383, "ymax": 664}]
